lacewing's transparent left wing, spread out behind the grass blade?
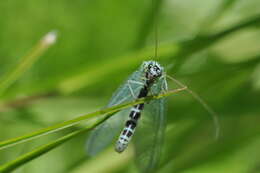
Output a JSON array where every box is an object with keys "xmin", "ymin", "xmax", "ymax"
[{"xmin": 86, "ymin": 70, "xmax": 142, "ymax": 155}]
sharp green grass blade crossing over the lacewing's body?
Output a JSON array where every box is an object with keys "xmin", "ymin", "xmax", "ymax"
[{"xmin": 0, "ymin": 88, "xmax": 186, "ymax": 150}]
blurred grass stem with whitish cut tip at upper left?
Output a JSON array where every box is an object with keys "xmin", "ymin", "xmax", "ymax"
[{"xmin": 0, "ymin": 31, "xmax": 56, "ymax": 96}]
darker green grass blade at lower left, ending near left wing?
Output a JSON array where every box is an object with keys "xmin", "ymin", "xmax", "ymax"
[{"xmin": 0, "ymin": 114, "xmax": 110, "ymax": 173}]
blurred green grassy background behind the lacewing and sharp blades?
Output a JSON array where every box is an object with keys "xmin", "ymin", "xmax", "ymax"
[{"xmin": 0, "ymin": 0, "xmax": 260, "ymax": 173}]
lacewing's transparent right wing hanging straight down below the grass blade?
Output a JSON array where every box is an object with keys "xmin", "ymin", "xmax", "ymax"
[{"xmin": 133, "ymin": 79, "xmax": 166, "ymax": 172}]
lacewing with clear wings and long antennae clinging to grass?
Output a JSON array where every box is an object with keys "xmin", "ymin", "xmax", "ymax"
[{"xmin": 87, "ymin": 1, "xmax": 219, "ymax": 172}]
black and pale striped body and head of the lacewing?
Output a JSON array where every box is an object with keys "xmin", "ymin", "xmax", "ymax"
[{"xmin": 115, "ymin": 61, "xmax": 163, "ymax": 153}]
